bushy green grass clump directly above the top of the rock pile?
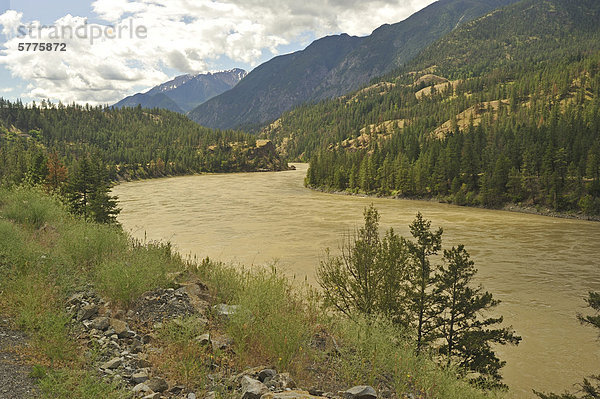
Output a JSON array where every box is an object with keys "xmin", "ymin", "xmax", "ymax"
[{"xmin": 94, "ymin": 239, "xmax": 184, "ymax": 306}]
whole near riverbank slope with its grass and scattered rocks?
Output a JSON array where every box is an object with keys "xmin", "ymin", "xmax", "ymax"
[{"xmin": 0, "ymin": 188, "xmax": 496, "ymax": 399}]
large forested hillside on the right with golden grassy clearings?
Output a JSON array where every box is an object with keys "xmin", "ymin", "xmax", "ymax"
[{"xmin": 263, "ymin": 0, "xmax": 600, "ymax": 215}]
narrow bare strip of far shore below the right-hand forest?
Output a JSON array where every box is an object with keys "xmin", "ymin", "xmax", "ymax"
[{"xmin": 307, "ymin": 186, "xmax": 600, "ymax": 222}]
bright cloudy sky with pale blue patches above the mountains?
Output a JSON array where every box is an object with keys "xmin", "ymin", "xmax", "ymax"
[{"xmin": 0, "ymin": 0, "xmax": 434, "ymax": 105}]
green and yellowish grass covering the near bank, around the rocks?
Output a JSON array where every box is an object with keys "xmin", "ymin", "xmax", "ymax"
[{"xmin": 0, "ymin": 189, "xmax": 501, "ymax": 399}]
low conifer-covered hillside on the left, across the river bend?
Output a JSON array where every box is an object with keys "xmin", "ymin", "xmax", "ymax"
[{"xmin": 0, "ymin": 99, "xmax": 287, "ymax": 183}]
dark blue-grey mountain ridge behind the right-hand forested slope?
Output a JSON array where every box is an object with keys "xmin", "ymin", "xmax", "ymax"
[{"xmin": 189, "ymin": 0, "xmax": 516, "ymax": 128}]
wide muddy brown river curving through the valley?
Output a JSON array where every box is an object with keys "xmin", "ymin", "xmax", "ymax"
[{"xmin": 113, "ymin": 164, "xmax": 600, "ymax": 398}]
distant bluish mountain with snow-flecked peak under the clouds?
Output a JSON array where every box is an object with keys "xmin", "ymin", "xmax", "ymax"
[{"xmin": 114, "ymin": 68, "xmax": 246, "ymax": 114}]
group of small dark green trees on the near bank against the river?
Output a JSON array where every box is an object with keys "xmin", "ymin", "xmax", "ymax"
[{"xmin": 317, "ymin": 205, "xmax": 521, "ymax": 389}]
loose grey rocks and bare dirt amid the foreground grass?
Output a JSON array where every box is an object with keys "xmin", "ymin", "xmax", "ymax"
[{"xmin": 66, "ymin": 282, "xmax": 385, "ymax": 399}]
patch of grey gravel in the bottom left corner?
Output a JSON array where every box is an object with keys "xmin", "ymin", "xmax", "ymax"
[{"xmin": 0, "ymin": 316, "xmax": 35, "ymax": 399}]
